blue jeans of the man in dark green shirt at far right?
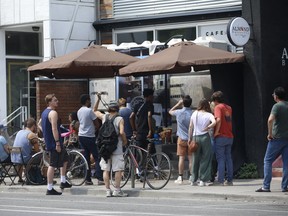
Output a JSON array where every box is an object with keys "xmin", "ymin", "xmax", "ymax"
[{"xmin": 263, "ymin": 139, "xmax": 288, "ymax": 190}]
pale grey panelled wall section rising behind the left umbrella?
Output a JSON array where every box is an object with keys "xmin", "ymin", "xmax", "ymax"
[{"xmin": 43, "ymin": 0, "xmax": 96, "ymax": 59}]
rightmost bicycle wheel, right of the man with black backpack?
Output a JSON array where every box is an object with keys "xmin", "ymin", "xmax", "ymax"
[{"xmin": 146, "ymin": 153, "xmax": 171, "ymax": 190}]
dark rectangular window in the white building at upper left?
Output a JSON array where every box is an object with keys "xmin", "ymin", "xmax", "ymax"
[{"xmin": 5, "ymin": 31, "xmax": 41, "ymax": 56}]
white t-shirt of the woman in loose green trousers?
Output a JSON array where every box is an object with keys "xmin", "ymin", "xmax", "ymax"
[{"xmin": 191, "ymin": 111, "xmax": 214, "ymax": 136}]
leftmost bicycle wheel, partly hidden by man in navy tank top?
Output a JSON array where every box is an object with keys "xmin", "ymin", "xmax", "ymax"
[{"xmin": 25, "ymin": 152, "xmax": 48, "ymax": 185}]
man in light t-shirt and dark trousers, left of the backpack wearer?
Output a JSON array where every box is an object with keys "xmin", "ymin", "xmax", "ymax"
[{"xmin": 77, "ymin": 94, "xmax": 103, "ymax": 185}]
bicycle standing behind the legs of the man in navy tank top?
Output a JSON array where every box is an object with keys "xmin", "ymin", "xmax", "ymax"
[{"xmin": 26, "ymin": 139, "xmax": 88, "ymax": 186}]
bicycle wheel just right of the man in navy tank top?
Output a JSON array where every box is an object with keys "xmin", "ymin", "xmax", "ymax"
[{"xmin": 66, "ymin": 150, "xmax": 88, "ymax": 186}]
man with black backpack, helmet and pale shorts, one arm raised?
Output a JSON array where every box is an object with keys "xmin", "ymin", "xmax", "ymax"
[{"xmin": 94, "ymin": 94, "xmax": 128, "ymax": 197}]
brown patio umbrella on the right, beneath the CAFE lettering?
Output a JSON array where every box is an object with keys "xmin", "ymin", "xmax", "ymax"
[{"xmin": 119, "ymin": 41, "xmax": 244, "ymax": 76}]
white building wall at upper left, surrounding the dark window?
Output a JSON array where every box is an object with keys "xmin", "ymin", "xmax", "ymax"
[{"xmin": 0, "ymin": 0, "xmax": 96, "ymax": 121}]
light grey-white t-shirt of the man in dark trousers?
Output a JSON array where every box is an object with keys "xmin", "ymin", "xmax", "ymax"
[{"xmin": 77, "ymin": 106, "xmax": 96, "ymax": 137}]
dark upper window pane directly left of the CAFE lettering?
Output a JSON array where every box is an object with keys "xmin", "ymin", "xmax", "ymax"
[{"xmin": 157, "ymin": 27, "xmax": 196, "ymax": 42}]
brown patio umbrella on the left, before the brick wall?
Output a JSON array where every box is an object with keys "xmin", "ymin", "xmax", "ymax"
[{"xmin": 28, "ymin": 45, "xmax": 138, "ymax": 79}]
